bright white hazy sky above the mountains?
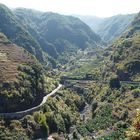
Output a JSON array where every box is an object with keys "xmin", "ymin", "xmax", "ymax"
[{"xmin": 0, "ymin": 0, "xmax": 140, "ymax": 17}]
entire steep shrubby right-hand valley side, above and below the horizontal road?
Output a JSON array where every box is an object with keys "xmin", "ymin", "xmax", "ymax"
[{"xmin": 63, "ymin": 13, "xmax": 140, "ymax": 140}]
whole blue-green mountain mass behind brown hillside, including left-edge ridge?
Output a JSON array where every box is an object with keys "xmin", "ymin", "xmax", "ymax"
[{"xmin": 0, "ymin": 5, "xmax": 102, "ymax": 67}]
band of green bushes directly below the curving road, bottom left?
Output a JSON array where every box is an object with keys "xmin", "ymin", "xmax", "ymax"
[{"xmin": 0, "ymin": 89, "xmax": 84, "ymax": 139}]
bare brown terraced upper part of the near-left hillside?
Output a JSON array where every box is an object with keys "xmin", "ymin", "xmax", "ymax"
[{"xmin": 0, "ymin": 34, "xmax": 34, "ymax": 82}]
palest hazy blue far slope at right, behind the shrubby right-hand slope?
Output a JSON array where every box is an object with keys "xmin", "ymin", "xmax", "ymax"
[{"xmin": 96, "ymin": 14, "xmax": 135, "ymax": 43}]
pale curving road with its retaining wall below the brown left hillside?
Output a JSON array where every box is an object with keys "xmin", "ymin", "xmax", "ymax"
[{"xmin": 0, "ymin": 84, "xmax": 62, "ymax": 119}]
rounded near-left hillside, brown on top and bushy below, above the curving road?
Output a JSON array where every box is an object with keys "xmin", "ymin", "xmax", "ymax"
[{"xmin": 0, "ymin": 33, "xmax": 44, "ymax": 112}]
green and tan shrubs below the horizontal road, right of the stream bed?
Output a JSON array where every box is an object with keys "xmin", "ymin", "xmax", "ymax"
[{"xmin": 70, "ymin": 81, "xmax": 140, "ymax": 140}]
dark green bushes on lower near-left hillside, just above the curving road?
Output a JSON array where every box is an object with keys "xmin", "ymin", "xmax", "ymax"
[{"xmin": 0, "ymin": 63, "xmax": 44, "ymax": 112}]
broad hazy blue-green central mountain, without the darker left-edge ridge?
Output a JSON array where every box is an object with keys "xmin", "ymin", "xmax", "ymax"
[{"xmin": 14, "ymin": 9, "xmax": 102, "ymax": 62}]
